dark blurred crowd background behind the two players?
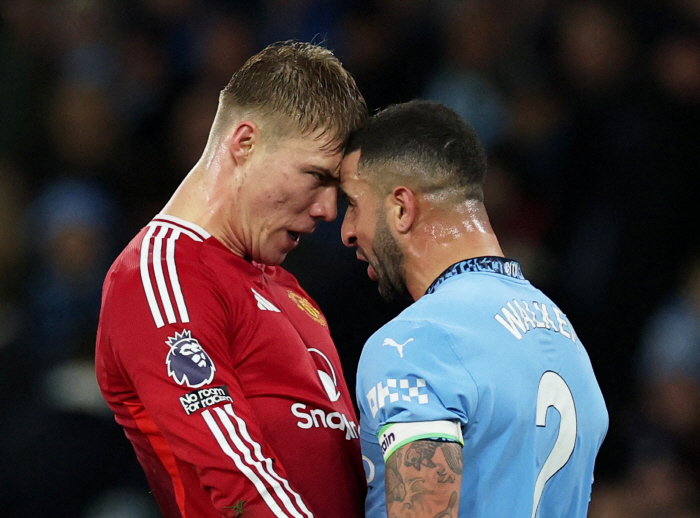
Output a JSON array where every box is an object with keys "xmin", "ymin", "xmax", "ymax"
[{"xmin": 0, "ymin": 0, "xmax": 700, "ymax": 518}]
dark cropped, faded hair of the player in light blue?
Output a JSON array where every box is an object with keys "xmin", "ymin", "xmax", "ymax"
[{"xmin": 345, "ymin": 100, "xmax": 486, "ymax": 201}]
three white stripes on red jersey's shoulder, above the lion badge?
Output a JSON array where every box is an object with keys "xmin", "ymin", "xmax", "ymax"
[{"xmin": 139, "ymin": 222, "xmax": 191, "ymax": 328}]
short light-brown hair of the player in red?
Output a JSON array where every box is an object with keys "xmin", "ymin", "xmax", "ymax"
[{"xmin": 220, "ymin": 41, "xmax": 367, "ymax": 147}]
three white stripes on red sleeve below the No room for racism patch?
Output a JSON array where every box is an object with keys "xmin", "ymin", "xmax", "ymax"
[{"xmin": 202, "ymin": 404, "xmax": 313, "ymax": 518}]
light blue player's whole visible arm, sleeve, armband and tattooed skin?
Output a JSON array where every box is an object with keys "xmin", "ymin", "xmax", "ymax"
[{"xmin": 357, "ymin": 321, "xmax": 477, "ymax": 518}]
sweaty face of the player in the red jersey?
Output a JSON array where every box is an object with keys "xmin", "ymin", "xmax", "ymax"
[{"xmin": 231, "ymin": 130, "xmax": 342, "ymax": 265}]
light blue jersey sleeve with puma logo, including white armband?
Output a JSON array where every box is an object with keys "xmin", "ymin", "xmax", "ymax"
[{"xmin": 357, "ymin": 320, "xmax": 478, "ymax": 458}]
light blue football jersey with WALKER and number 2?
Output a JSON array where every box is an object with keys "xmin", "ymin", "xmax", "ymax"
[{"xmin": 357, "ymin": 257, "xmax": 608, "ymax": 518}]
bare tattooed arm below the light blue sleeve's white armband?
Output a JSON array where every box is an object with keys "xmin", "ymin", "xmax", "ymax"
[{"xmin": 385, "ymin": 440, "xmax": 462, "ymax": 518}]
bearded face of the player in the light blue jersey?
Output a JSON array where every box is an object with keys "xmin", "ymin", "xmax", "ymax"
[{"xmin": 340, "ymin": 151, "xmax": 410, "ymax": 300}]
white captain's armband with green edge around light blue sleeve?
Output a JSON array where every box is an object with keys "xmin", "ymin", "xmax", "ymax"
[{"xmin": 377, "ymin": 421, "xmax": 464, "ymax": 462}]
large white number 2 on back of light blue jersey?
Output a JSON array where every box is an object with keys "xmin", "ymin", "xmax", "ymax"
[{"xmin": 532, "ymin": 371, "xmax": 577, "ymax": 518}]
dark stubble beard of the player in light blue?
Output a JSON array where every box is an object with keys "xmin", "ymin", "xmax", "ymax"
[{"xmin": 371, "ymin": 217, "xmax": 411, "ymax": 301}]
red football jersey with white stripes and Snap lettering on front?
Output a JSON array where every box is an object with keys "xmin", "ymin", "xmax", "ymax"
[{"xmin": 96, "ymin": 216, "xmax": 365, "ymax": 518}]
